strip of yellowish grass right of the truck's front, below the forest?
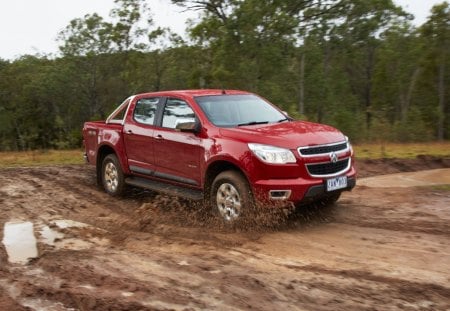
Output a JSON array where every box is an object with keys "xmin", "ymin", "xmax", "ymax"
[{"xmin": 353, "ymin": 141, "xmax": 450, "ymax": 159}]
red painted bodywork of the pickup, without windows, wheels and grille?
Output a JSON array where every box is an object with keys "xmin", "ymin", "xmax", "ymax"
[{"xmin": 83, "ymin": 90, "xmax": 356, "ymax": 203}]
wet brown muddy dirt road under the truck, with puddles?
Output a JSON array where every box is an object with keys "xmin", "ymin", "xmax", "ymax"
[{"xmin": 0, "ymin": 163, "xmax": 450, "ymax": 310}]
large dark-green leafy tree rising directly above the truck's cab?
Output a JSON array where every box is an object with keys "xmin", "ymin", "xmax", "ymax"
[{"xmin": 173, "ymin": 0, "xmax": 336, "ymax": 100}]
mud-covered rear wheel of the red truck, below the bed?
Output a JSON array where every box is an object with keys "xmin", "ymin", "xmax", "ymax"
[{"xmin": 101, "ymin": 154, "xmax": 125, "ymax": 196}]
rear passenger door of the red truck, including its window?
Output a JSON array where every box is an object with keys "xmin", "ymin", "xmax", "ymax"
[{"xmin": 123, "ymin": 97, "xmax": 162, "ymax": 175}]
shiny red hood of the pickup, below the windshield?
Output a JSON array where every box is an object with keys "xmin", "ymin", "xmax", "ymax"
[{"xmin": 220, "ymin": 121, "xmax": 345, "ymax": 149}]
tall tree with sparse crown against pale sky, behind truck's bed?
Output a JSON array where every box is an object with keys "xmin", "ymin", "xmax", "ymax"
[{"xmin": 58, "ymin": 0, "xmax": 152, "ymax": 119}]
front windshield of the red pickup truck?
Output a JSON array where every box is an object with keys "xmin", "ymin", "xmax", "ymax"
[{"xmin": 195, "ymin": 94, "xmax": 287, "ymax": 127}]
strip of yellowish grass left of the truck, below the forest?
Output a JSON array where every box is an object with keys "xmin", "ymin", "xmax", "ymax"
[{"xmin": 0, "ymin": 149, "xmax": 84, "ymax": 167}]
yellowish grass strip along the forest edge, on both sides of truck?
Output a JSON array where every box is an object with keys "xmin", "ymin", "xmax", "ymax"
[{"xmin": 0, "ymin": 142, "xmax": 450, "ymax": 167}]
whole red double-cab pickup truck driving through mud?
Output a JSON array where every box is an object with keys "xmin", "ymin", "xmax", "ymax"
[{"xmin": 83, "ymin": 90, "xmax": 356, "ymax": 223}]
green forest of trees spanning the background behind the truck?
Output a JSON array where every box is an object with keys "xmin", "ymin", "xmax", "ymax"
[{"xmin": 0, "ymin": 0, "xmax": 450, "ymax": 151}]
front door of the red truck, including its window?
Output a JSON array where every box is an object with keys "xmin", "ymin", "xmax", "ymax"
[{"xmin": 154, "ymin": 98, "xmax": 203, "ymax": 186}]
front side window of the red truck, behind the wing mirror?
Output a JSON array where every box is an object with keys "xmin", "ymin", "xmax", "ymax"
[{"xmin": 162, "ymin": 98, "xmax": 195, "ymax": 129}]
